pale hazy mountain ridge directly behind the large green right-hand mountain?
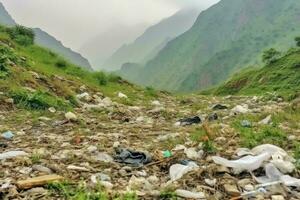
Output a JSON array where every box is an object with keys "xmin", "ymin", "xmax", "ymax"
[{"xmin": 102, "ymin": 9, "xmax": 199, "ymax": 71}]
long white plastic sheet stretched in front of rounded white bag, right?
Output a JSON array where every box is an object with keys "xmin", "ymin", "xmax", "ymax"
[{"xmin": 212, "ymin": 153, "xmax": 271, "ymax": 172}]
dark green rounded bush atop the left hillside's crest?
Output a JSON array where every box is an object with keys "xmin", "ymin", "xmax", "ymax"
[{"xmin": 7, "ymin": 25, "xmax": 35, "ymax": 46}]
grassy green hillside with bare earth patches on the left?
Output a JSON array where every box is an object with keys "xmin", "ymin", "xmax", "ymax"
[{"xmin": 0, "ymin": 26, "xmax": 159, "ymax": 110}]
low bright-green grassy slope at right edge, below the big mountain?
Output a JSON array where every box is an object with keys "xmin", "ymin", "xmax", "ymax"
[{"xmin": 213, "ymin": 49, "xmax": 300, "ymax": 99}]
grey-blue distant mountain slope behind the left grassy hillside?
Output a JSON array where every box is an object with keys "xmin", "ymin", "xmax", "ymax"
[{"xmin": 0, "ymin": 2, "xmax": 92, "ymax": 70}]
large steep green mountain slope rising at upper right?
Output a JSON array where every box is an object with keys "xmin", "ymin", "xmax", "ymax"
[{"xmin": 123, "ymin": 0, "xmax": 300, "ymax": 91}]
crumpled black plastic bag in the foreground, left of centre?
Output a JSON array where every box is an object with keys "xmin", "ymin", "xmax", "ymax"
[{"xmin": 115, "ymin": 149, "xmax": 152, "ymax": 166}]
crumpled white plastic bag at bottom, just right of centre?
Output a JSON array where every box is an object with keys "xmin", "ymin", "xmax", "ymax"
[{"xmin": 169, "ymin": 162, "xmax": 199, "ymax": 181}]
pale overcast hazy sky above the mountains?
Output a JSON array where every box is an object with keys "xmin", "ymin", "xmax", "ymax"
[{"xmin": 0, "ymin": 0, "xmax": 218, "ymax": 59}]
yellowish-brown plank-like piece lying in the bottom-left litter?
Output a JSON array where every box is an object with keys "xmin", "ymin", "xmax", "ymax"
[{"xmin": 17, "ymin": 175, "xmax": 64, "ymax": 190}]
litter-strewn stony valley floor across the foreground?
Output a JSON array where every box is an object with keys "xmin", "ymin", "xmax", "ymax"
[{"xmin": 0, "ymin": 87, "xmax": 300, "ymax": 200}]
